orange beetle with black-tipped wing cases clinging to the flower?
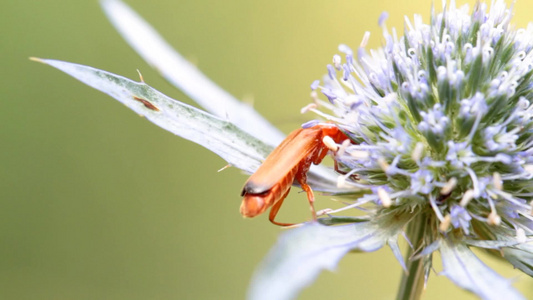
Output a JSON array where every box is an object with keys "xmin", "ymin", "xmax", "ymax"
[{"xmin": 241, "ymin": 124, "xmax": 348, "ymax": 226}]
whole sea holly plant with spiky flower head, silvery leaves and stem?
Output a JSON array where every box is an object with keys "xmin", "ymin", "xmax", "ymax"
[{"xmin": 35, "ymin": 0, "xmax": 533, "ymax": 299}]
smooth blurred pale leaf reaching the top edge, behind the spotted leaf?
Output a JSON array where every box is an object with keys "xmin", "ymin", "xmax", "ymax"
[{"xmin": 101, "ymin": 0, "xmax": 284, "ymax": 146}]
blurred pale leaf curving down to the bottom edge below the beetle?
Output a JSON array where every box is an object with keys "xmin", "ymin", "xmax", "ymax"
[{"xmin": 248, "ymin": 216, "xmax": 409, "ymax": 300}]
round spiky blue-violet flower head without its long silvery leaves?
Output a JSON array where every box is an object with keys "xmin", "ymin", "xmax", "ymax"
[{"xmin": 296, "ymin": 0, "xmax": 533, "ymax": 298}]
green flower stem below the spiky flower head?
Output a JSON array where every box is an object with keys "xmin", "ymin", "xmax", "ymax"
[{"xmin": 396, "ymin": 213, "xmax": 428, "ymax": 300}]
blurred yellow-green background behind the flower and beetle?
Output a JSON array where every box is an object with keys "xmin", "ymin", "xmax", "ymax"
[{"xmin": 0, "ymin": 0, "xmax": 533, "ymax": 299}]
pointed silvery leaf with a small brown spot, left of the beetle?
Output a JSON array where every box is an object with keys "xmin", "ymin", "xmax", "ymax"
[{"xmin": 34, "ymin": 59, "xmax": 271, "ymax": 173}]
